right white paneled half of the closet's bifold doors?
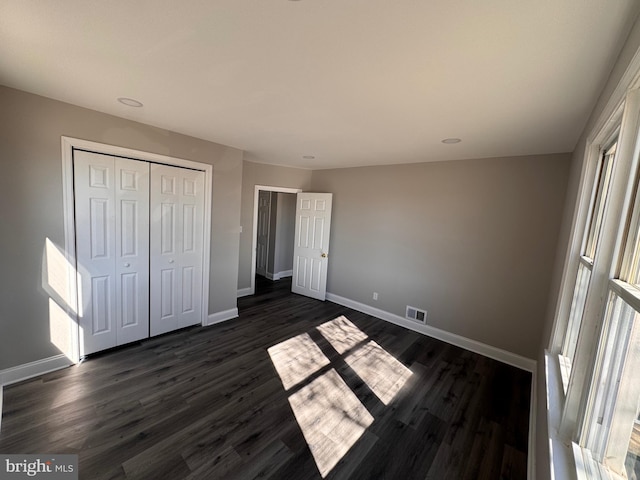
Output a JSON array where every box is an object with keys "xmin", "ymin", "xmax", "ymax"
[{"xmin": 150, "ymin": 164, "xmax": 204, "ymax": 336}]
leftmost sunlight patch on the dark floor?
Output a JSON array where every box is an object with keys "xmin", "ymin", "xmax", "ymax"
[{"xmin": 267, "ymin": 333, "xmax": 329, "ymax": 390}]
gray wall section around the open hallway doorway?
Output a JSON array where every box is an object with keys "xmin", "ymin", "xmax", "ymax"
[{"xmin": 238, "ymin": 160, "xmax": 311, "ymax": 289}]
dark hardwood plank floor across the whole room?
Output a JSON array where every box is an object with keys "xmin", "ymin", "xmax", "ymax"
[{"xmin": 0, "ymin": 280, "xmax": 531, "ymax": 480}]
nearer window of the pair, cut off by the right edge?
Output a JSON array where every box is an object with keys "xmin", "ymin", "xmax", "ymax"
[{"xmin": 582, "ymin": 158, "xmax": 640, "ymax": 479}]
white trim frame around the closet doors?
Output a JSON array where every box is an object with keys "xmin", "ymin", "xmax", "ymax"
[{"xmin": 61, "ymin": 136, "xmax": 213, "ymax": 363}]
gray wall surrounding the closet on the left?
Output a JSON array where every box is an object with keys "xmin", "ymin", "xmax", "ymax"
[{"xmin": 0, "ymin": 87, "xmax": 242, "ymax": 370}]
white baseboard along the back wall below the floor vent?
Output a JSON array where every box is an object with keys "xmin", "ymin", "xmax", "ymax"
[{"xmin": 327, "ymin": 293, "xmax": 536, "ymax": 373}]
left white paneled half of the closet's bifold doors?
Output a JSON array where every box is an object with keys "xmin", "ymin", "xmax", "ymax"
[{"xmin": 74, "ymin": 151, "xmax": 149, "ymax": 356}]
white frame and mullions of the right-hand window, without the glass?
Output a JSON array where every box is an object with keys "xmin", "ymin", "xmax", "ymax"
[{"xmin": 548, "ymin": 82, "xmax": 640, "ymax": 478}]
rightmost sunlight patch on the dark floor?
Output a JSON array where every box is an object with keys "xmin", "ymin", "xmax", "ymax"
[{"xmin": 345, "ymin": 341, "xmax": 412, "ymax": 405}]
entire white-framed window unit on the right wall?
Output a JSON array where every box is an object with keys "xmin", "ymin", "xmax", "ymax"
[{"xmin": 549, "ymin": 84, "xmax": 640, "ymax": 480}]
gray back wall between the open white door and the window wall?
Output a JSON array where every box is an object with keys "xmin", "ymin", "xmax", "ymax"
[{"xmin": 312, "ymin": 154, "xmax": 570, "ymax": 358}]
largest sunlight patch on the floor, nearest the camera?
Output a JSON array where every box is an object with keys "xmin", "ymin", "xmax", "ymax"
[{"xmin": 289, "ymin": 369, "xmax": 373, "ymax": 478}]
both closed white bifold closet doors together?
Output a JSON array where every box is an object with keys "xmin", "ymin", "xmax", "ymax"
[{"xmin": 74, "ymin": 150, "xmax": 204, "ymax": 356}]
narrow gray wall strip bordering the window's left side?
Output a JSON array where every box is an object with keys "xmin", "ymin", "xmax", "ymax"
[{"xmin": 536, "ymin": 12, "xmax": 640, "ymax": 480}]
